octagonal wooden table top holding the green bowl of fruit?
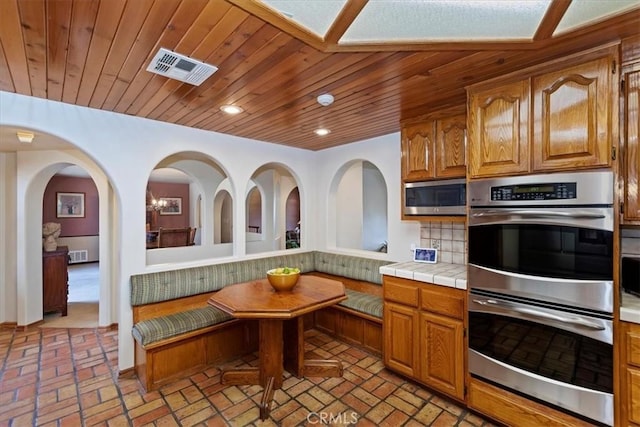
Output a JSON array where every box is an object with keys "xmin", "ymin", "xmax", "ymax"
[{"xmin": 209, "ymin": 275, "xmax": 347, "ymax": 319}]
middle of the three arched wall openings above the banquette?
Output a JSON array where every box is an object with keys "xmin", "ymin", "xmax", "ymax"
[{"xmin": 245, "ymin": 163, "xmax": 301, "ymax": 254}]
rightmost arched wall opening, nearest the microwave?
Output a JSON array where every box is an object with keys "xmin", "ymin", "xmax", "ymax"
[{"xmin": 330, "ymin": 160, "xmax": 388, "ymax": 252}]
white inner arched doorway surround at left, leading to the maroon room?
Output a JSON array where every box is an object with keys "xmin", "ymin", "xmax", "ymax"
[{"xmin": 16, "ymin": 143, "xmax": 119, "ymax": 327}]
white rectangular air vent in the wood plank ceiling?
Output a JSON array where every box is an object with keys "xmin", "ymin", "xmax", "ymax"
[{"xmin": 147, "ymin": 47, "xmax": 218, "ymax": 86}]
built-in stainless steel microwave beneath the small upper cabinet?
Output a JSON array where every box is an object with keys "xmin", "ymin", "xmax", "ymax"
[{"xmin": 403, "ymin": 178, "xmax": 467, "ymax": 216}]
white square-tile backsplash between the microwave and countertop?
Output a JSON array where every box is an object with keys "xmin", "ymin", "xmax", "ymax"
[{"xmin": 420, "ymin": 221, "xmax": 467, "ymax": 264}]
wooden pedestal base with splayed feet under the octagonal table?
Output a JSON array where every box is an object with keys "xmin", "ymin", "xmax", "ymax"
[{"xmin": 221, "ymin": 317, "xmax": 343, "ymax": 421}]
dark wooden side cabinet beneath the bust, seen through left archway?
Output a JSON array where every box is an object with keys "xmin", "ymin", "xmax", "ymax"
[{"xmin": 42, "ymin": 246, "xmax": 69, "ymax": 316}]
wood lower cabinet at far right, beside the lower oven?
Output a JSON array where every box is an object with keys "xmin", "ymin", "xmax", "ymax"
[{"xmin": 616, "ymin": 322, "xmax": 640, "ymax": 426}]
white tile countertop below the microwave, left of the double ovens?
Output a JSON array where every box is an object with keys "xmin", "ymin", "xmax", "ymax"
[{"xmin": 380, "ymin": 261, "xmax": 467, "ymax": 289}]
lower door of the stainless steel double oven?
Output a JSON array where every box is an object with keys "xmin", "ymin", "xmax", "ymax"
[{"xmin": 469, "ymin": 291, "xmax": 613, "ymax": 425}]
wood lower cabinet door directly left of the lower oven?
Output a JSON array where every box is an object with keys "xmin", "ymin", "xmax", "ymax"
[{"xmin": 419, "ymin": 312, "xmax": 464, "ymax": 400}]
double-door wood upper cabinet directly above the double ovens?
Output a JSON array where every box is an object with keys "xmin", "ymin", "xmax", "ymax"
[{"xmin": 468, "ymin": 45, "xmax": 618, "ymax": 178}]
